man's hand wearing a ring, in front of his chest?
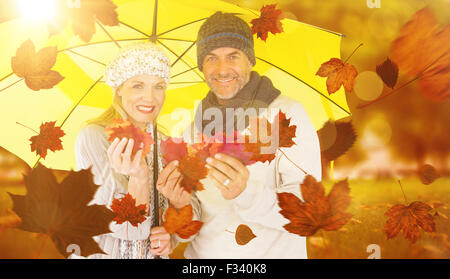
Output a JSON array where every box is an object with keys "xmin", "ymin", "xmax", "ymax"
[{"xmin": 206, "ymin": 153, "xmax": 250, "ymax": 200}]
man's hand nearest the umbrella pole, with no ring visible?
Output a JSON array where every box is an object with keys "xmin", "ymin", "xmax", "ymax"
[{"xmin": 156, "ymin": 161, "xmax": 191, "ymax": 209}]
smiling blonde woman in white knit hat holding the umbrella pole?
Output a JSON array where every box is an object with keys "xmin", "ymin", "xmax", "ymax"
[{"xmin": 75, "ymin": 43, "xmax": 174, "ymax": 258}]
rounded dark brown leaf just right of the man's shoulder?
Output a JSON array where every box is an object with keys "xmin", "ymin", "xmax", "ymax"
[{"xmin": 317, "ymin": 120, "xmax": 356, "ymax": 161}]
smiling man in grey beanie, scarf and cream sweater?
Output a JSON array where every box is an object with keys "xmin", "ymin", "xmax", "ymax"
[{"xmin": 160, "ymin": 12, "xmax": 321, "ymax": 258}]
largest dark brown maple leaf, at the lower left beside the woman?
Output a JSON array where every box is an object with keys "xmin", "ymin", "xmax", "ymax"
[{"xmin": 9, "ymin": 164, "xmax": 114, "ymax": 257}]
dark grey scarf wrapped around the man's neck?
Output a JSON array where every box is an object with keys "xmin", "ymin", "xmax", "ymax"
[{"xmin": 195, "ymin": 71, "xmax": 281, "ymax": 136}]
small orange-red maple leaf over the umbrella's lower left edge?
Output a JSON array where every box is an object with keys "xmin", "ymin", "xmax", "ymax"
[{"xmin": 30, "ymin": 121, "xmax": 66, "ymax": 159}]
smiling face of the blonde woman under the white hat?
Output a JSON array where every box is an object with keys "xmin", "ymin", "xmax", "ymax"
[{"xmin": 117, "ymin": 75, "xmax": 167, "ymax": 128}]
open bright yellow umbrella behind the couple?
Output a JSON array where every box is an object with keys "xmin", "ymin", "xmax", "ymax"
[{"xmin": 0, "ymin": 0, "xmax": 350, "ymax": 170}]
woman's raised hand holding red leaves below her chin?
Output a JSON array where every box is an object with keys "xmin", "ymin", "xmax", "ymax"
[{"xmin": 107, "ymin": 138, "xmax": 150, "ymax": 181}]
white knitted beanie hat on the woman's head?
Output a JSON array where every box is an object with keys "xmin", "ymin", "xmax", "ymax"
[{"xmin": 105, "ymin": 42, "xmax": 170, "ymax": 90}]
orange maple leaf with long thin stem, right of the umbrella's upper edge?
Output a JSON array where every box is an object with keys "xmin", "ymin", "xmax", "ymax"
[{"xmin": 316, "ymin": 58, "xmax": 358, "ymax": 95}]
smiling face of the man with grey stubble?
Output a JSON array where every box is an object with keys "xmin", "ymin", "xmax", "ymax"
[{"xmin": 203, "ymin": 47, "xmax": 252, "ymax": 100}]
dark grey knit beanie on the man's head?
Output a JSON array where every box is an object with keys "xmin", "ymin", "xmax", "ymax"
[{"xmin": 197, "ymin": 12, "xmax": 256, "ymax": 71}]
